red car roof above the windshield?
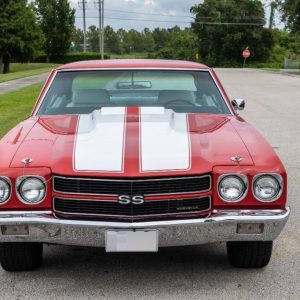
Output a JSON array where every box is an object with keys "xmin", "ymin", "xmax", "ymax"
[{"xmin": 57, "ymin": 59, "xmax": 209, "ymax": 70}]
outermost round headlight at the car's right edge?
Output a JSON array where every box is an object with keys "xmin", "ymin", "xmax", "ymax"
[{"xmin": 253, "ymin": 175, "xmax": 281, "ymax": 202}]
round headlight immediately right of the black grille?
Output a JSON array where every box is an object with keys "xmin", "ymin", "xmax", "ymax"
[{"xmin": 218, "ymin": 175, "xmax": 248, "ymax": 202}]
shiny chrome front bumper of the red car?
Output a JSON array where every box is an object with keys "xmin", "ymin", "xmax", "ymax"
[{"xmin": 0, "ymin": 208, "xmax": 290, "ymax": 247}]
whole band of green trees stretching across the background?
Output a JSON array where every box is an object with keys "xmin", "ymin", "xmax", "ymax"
[{"xmin": 0, "ymin": 0, "xmax": 300, "ymax": 73}]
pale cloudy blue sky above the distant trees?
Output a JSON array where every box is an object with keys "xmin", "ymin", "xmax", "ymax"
[{"xmin": 70, "ymin": 0, "xmax": 280, "ymax": 30}]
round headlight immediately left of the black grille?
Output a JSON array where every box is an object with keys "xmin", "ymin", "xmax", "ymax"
[{"xmin": 19, "ymin": 177, "xmax": 46, "ymax": 204}]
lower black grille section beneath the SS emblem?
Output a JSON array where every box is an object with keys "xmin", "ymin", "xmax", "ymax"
[{"xmin": 54, "ymin": 196, "xmax": 210, "ymax": 217}]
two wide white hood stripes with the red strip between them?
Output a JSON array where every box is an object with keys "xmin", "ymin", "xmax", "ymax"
[{"xmin": 73, "ymin": 107, "xmax": 191, "ymax": 173}]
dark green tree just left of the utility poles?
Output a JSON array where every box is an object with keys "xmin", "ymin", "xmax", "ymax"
[{"xmin": 35, "ymin": 0, "xmax": 75, "ymax": 61}]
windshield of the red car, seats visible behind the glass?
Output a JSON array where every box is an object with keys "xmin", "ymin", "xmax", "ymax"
[{"xmin": 37, "ymin": 70, "xmax": 230, "ymax": 115}]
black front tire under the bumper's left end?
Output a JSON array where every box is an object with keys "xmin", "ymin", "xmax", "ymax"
[{"xmin": 0, "ymin": 243, "xmax": 43, "ymax": 271}]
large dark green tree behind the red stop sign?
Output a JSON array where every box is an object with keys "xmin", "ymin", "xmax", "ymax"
[{"xmin": 191, "ymin": 0, "xmax": 274, "ymax": 65}]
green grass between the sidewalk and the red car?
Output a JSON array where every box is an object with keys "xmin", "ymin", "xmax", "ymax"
[{"xmin": 0, "ymin": 83, "xmax": 43, "ymax": 138}]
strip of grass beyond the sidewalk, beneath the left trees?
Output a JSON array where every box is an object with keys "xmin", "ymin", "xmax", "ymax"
[{"xmin": 0, "ymin": 63, "xmax": 58, "ymax": 82}]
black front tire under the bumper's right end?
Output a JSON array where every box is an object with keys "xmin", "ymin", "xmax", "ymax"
[{"xmin": 227, "ymin": 241, "xmax": 273, "ymax": 268}]
